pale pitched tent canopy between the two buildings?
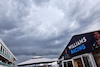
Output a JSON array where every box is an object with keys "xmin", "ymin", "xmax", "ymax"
[{"xmin": 18, "ymin": 56, "xmax": 58, "ymax": 66}]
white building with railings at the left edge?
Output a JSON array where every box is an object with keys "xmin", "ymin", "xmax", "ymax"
[{"xmin": 0, "ymin": 39, "xmax": 17, "ymax": 67}]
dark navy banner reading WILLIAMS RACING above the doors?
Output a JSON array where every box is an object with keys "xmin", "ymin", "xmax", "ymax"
[{"xmin": 59, "ymin": 31, "xmax": 100, "ymax": 59}]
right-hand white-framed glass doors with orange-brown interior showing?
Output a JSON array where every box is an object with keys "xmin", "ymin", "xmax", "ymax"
[{"xmin": 73, "ymin": 54, "xmax": 94, "ymax": 67}]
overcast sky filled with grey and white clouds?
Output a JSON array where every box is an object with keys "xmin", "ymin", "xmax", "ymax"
[{"xmin": 0, "ymin": 0, "xmax": 100, "ymax": 66}]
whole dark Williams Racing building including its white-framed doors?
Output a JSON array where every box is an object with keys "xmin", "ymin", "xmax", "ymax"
[{"xmin": 58, "ymin": 31, "xmax": 100, "ymax": 67}]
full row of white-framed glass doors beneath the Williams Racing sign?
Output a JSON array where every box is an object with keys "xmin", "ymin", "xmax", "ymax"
[{"xmin": 62, "ymin": 54, "xmax": 95, "ymax": 67}]
